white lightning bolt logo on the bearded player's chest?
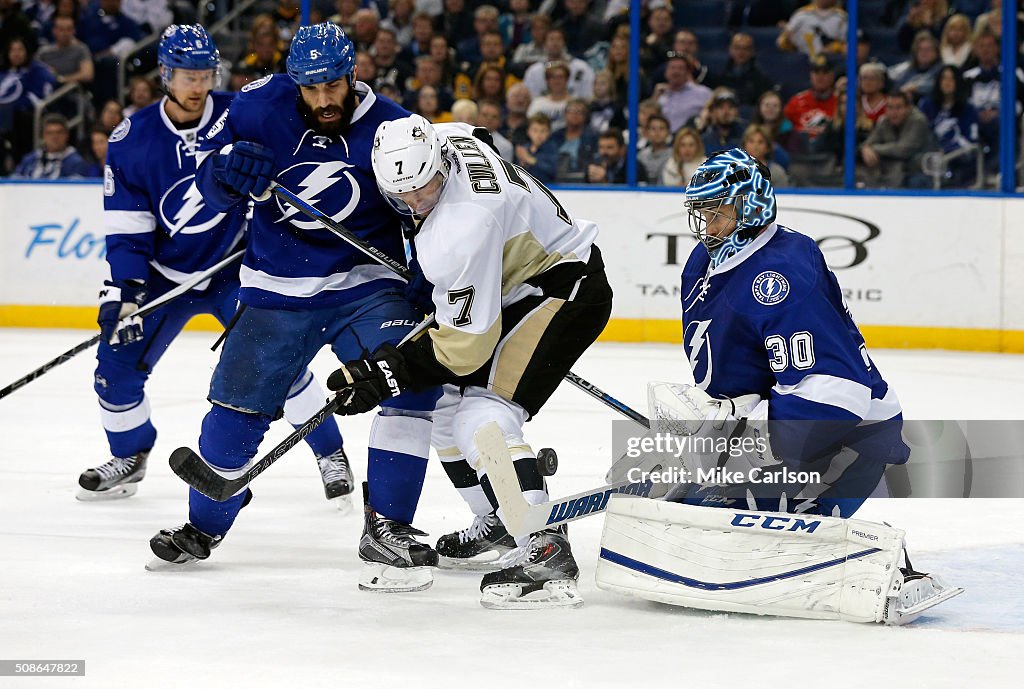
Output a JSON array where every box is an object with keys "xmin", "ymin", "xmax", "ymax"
[{"xmin": 275, "ymin": 161, "xmax": 359, "ymax": 229}]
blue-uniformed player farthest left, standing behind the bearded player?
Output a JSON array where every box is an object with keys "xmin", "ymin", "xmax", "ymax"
[{"xmin": 79, "ymin": 25, "xmax": 352, "ymax": 500}]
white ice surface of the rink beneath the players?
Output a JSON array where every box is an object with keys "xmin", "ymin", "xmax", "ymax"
[{"xmin": 0, "ymin": 330, "xmax": 1024, "ymax": 689}]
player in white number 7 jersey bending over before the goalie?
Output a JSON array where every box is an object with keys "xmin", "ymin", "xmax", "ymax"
[{"xmin": 328, "ymin": 115, "xmax": 611, "ymax": 608}]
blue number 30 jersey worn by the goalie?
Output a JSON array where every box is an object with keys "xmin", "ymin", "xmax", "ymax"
[{"xmin": 681, "ymin": 224, "xmax": 908, "ymax": 464}]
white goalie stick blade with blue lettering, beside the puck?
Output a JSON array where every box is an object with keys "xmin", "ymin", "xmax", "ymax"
[{"xmin": 475, "ymin": 422, "xmax": 653, "ymax": 536}]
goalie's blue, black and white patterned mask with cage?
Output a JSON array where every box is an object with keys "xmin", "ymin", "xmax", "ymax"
[{"xmin": 686, "ymin": 148, "xmax": 777, "ymax": 251}]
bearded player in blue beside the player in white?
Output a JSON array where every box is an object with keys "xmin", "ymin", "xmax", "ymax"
[{"xmin": 151, "ymin": 23, "xmax": 440, "ymax": 591}]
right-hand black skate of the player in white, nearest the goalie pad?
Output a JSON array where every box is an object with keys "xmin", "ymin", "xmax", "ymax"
[{"xmin": 480, "ymin": 531, "xmax": 583, "ymax": 610}]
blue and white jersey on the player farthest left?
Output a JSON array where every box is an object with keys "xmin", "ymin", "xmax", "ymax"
[{"xmin": 103, "ymin": 93, "xmax": 246, "ymax": 282}]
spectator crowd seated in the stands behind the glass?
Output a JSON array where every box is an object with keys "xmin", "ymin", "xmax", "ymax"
[{"xmin": 0, "ymin": 0, "xmax": 1024, "ymax": 187}]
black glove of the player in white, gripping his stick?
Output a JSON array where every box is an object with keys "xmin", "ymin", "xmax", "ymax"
[{"xmin": 327, "ymin": 345, "xmax": 409, "ymax": 416}]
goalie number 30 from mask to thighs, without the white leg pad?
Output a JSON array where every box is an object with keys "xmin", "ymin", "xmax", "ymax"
[{"xmin": 653, "ymin": 148, "xmax": 908, "ymax": 516}]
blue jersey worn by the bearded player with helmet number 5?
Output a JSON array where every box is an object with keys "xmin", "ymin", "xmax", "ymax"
[{"xmin": 199, "ymin": 75, "xmax": 409, "ymax": 309}]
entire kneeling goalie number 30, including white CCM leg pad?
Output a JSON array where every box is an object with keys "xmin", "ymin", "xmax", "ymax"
[{"xmin": 597, "ymin": 148, "xmax": 963, "ymax": 625}]
